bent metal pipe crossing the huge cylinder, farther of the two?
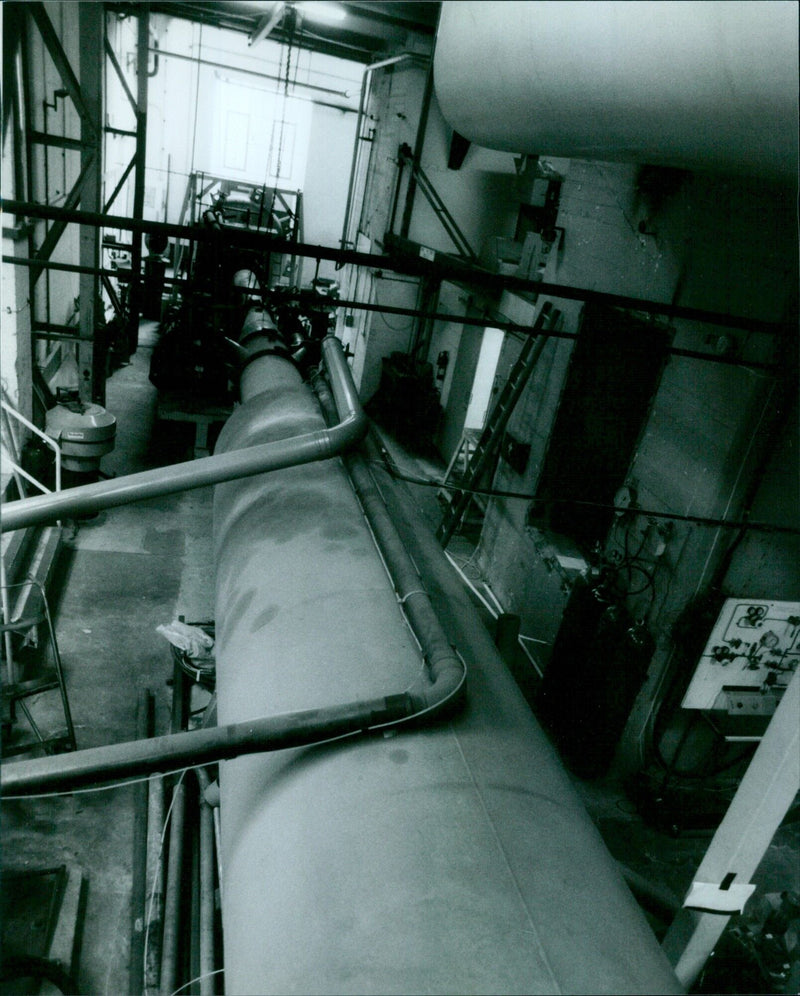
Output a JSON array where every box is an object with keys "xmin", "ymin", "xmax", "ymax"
[{"xmin": 0, "ymin": 336, "xmax": 367, "ymax": 532}]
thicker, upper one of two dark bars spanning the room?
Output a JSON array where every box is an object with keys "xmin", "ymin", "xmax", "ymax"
[{"xmin": 0, "ymin": 198, "xmax": 790, "ymax": 335}]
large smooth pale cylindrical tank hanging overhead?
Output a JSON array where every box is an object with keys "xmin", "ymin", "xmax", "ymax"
[{"xmin": 434, "ymin": 0, "xmax": 798, "ymax": 184}]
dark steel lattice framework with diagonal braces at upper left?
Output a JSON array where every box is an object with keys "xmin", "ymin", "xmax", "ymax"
[{"xmin": 3, "ymin": 0, "xmax": 149, "ymax": 404}]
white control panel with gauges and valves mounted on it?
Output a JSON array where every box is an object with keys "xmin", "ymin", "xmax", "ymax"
[{"xmin": 682, "ymin": 598, "xmax": 800, "ymax": 739}]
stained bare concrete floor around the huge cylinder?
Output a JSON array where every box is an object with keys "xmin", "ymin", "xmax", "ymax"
[{"xmin": 2, "ymin": 325, "xmax": 800, "ymax": 994}]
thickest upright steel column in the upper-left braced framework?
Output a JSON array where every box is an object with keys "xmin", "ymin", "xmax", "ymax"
[{"xmin": 78, "ymin": 3, "xmax": 106, "ymax": 404}]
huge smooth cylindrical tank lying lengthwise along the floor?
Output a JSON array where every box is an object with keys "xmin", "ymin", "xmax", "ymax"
[{"xmin": 214, "ymin": 340, "xmax": 681, "ymax": 993}]
